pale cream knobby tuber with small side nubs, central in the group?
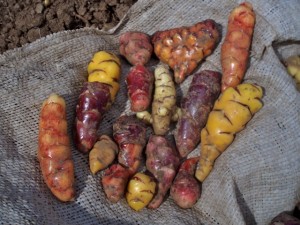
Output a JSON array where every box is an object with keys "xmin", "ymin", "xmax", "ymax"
[{"xmin": 136, "ymin": 64, "xmax": 180, "ymax": 135}]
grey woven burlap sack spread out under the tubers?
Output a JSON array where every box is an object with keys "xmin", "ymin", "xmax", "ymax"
[{"xmin": 0, "ymin": 0, "xmax": 300, "ymax": 225}]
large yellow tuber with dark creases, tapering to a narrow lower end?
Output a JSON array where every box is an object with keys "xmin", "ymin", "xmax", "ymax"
[{"xmin": 196, "ymin": 83, "xmax": 263, "ymax": 182}]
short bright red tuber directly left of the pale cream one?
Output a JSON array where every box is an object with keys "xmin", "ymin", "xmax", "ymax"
[{"xmin": 126, "ymin": 65, "xmax": 154, "ymax": 112}]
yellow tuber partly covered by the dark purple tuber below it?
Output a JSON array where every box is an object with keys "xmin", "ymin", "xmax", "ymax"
[{"xmin": 87, "ymin": 51, "xmax": 121, "ymax": 101}]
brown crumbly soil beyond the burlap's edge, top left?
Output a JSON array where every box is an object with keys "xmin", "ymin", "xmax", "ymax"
[{"xmin": 0, "ymin": 0, "xmax": 137, "ymax": 54}]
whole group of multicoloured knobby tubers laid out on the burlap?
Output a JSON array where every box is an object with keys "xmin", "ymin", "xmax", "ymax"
[{"xmin": 38, "ymin": 2, "xmax": 263, "ymax": 211}]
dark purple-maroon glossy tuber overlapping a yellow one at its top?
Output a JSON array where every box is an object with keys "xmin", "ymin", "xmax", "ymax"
[{"xmin": 74, "ymin": 82, "xmax": 112, "ymax": 153}]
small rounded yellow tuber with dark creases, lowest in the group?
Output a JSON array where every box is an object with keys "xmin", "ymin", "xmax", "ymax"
[{"xmin": 126, "ymin": 173, "xmax": 156, "ymax": 211}]
